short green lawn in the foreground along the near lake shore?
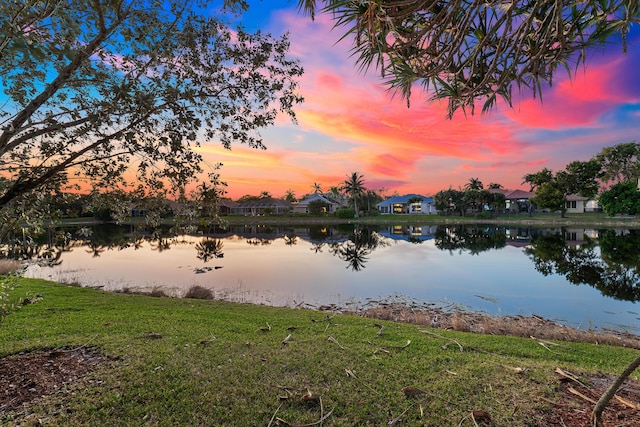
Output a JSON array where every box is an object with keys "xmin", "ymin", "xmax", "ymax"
[{"xmin": 0, "ymin": 279, "xmax": 637, "ymax": 426}]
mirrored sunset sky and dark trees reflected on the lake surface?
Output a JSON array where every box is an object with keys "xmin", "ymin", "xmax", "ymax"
[{"xmin": 8, "ymin": 224, "xmax": 640, "ymax": 330}]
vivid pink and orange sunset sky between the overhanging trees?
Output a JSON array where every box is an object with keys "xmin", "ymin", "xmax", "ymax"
[{"xmin": 196, "ymin": 0, "xmax": 640, "ymax": 199}]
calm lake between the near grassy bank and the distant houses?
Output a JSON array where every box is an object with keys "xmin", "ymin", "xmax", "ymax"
[{"xmin": 22, "ymin": 225, "xmax": 640, "ymax": 333}]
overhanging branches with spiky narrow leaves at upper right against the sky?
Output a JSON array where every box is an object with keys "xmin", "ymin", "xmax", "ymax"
[{"xmin": 298, "ymin": 0, "xmax": 640, "ymax": 116}]
